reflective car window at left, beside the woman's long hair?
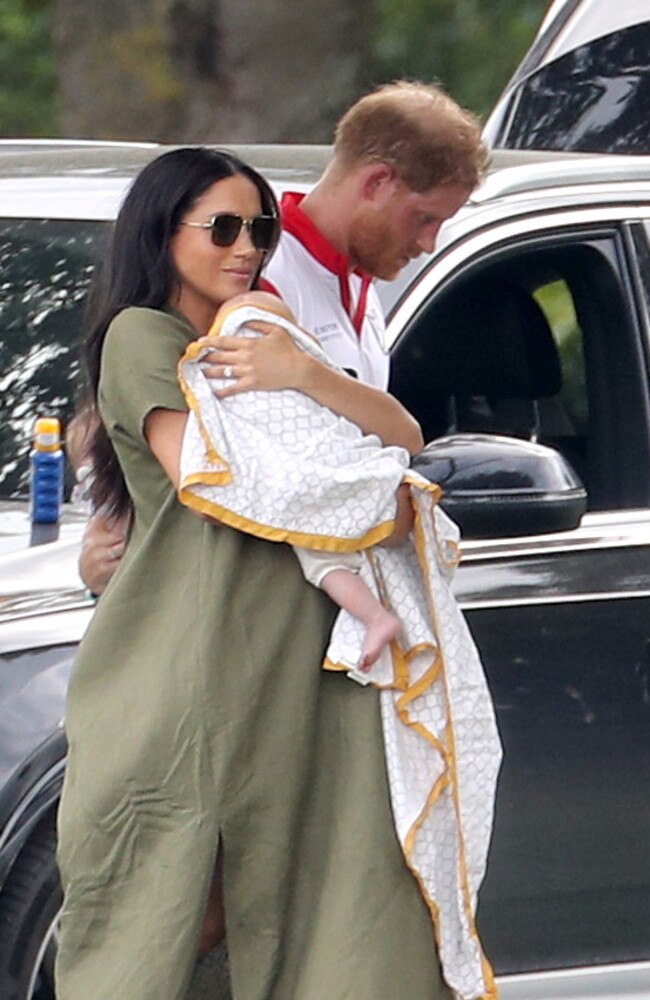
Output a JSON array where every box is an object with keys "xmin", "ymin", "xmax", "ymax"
[{"xmin": 0, "ymin": 219, "xmax": 107, "ymax": 497}]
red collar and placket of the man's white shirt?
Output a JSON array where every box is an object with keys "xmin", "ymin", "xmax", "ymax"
[{"xmin": 280, "ymin": 191, "xmax": 372, "ymax": 336}]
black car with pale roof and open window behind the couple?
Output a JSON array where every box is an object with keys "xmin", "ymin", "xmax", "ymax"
[{"xmin": 0, "ymin": 143, "xmax": 650, "ymax": 1000}]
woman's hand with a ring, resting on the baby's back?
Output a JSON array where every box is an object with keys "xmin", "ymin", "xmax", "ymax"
[{"xmin": 199, "ymin": 322, "xmax": 309, "ymax": 399}]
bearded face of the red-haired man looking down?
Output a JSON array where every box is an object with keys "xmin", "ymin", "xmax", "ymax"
[{"xmin": 348, "ymin": 180, "xmax": 471, "ymax": 281}]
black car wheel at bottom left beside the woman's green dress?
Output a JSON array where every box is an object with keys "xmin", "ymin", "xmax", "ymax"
[{"xmin": 0, "ymin": 815, "xmax": 62, "ymax": 1000}]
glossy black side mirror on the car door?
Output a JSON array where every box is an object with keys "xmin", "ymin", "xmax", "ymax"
[{"xmin": 412, "ymin": 434, "xmax": 587, "ymax": 538}]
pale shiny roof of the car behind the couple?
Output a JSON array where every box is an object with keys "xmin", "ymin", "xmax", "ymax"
[{"xmin": 0, "ymin": 139, "xmax": 650, "ymax": 219}]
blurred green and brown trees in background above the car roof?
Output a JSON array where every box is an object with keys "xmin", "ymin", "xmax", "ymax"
[{"xmin": 0, "ymin": 0, "xmax": 547, "ymax": 141}]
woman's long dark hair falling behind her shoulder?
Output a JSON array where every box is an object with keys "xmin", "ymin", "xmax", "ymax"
[{"xmin": 86, "ymin": 147, "xmax": 278, "ymax": 518}]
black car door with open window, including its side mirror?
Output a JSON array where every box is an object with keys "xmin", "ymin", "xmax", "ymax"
[{"xmin": 389, "ymin": 208, "xmax": 650, "ymax": 980}]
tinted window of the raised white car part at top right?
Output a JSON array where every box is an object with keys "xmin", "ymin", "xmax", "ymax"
[{"xmin": 495, "ymin": 22, "xmax": 650, "ymax": 153}]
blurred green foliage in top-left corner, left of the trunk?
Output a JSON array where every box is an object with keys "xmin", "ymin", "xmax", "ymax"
[{"xmin": 0, "ymin": 0, "xmax": 59, "ymax": 138}]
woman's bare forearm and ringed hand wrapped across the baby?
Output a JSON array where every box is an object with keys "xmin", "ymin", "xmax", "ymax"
[{"xmin": 197, "ymin": 323, "xmax": 424, "ymax": 455}]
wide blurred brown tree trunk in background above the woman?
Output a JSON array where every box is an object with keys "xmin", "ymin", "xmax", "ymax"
[{"xmin": 52, "ymin": 0, "xmax": 374, "ymax": 142}]
